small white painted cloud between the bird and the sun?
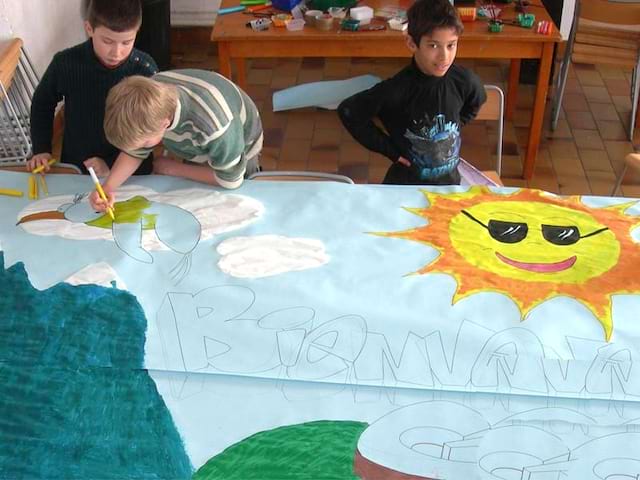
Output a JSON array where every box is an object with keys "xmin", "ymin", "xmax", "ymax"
[{"xmin": 217, "ymin": 235, "xmax": 329, "ymax": 278}]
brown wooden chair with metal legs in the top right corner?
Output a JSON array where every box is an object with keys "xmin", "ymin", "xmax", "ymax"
[{"xmin": 551, "ymin": 0, "xmax": 640, "ymax": 139}]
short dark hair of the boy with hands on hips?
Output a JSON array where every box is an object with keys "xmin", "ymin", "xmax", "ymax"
[{"xmin": 407, "ymin": 0, "xmax": 464, "ymax": 47}]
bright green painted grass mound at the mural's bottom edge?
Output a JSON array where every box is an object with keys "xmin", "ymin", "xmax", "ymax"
[{"xmin": 193, "ymin": 421, "xmax": 367, "ymax": 480}]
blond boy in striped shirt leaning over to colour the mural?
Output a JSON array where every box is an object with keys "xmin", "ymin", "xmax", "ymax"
[{"xmin": 90, "ymin": 70, "xmax": 262, "ymax": 211}]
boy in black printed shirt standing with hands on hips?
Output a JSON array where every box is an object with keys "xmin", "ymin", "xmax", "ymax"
[{"xmin": 338, "ymin": 0, "xmax": 486, "ymax": 185}]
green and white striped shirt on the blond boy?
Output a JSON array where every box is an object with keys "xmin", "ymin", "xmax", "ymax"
[{"xmin": 128, "ymin": 69, "xmax": 262, "ymax": 188}]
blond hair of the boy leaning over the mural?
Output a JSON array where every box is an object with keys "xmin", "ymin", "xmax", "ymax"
[{"xmin": 104, "ymin": 75, "xmax": 178, "ymax": 151}]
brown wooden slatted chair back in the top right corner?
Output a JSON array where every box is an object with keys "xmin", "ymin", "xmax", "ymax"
[{"xmin": 571, "ymin": 0, "xmax": 640, "ymax": 68}]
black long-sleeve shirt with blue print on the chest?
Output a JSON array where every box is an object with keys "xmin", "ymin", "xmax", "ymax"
[{"xmin": 338, "ymin": 61, "xmax": 487, "ymax": 183}]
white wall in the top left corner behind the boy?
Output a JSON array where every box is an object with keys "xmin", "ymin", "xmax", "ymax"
[{"xmin": 0, "ymin": 0, "xmax": 86, "ymax": 75}]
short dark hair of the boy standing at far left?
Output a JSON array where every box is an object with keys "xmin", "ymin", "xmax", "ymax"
[{"xmin": 83, "ymin": 0, "xmax": 142, "ymax": 32}]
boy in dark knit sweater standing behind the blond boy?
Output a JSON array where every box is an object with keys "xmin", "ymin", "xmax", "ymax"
[{"xmin": 27, "ymin": 0, "xmax": 158, "ymax": 176}]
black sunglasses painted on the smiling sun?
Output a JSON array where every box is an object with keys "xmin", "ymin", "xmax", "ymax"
[{"xmin": 462, "ymin": 210, "xmax": 609, "ymax": 245}]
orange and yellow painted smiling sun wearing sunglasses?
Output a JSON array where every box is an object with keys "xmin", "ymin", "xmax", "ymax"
[{"xmin": 377, "ymin": 187, "xmax": 640, "ymax": 341}]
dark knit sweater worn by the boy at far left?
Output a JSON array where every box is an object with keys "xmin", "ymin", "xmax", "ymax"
[{"xmin": 31, "ymin": 39, "xmax": 158, "ymax": 173}]
